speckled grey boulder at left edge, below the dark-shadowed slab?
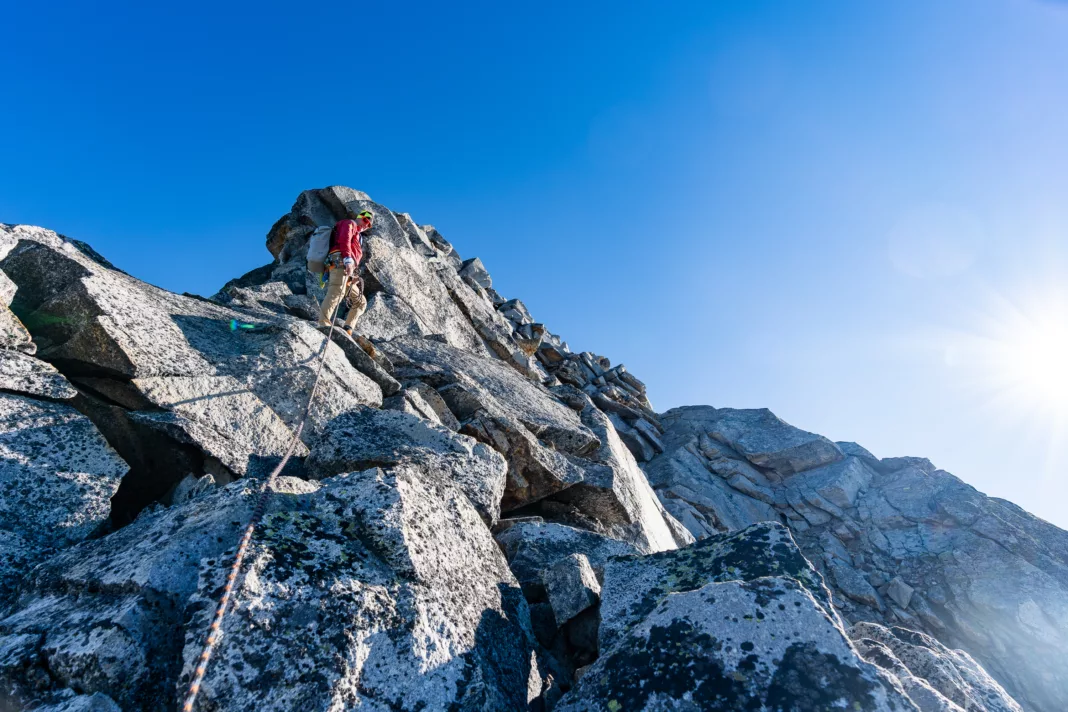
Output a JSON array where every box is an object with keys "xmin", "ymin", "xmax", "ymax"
[{"xmin": 0, "ymin": 394, "xmax": 128, "ymax": 610}]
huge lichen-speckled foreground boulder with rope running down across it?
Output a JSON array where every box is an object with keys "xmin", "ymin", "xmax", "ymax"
[{"xmin": 0, "ymin": 463, "xmax": 540, "ymax": 712}]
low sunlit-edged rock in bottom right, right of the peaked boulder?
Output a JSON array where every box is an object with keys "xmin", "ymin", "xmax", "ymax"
[{"xmin": 849, "ymin": 623, "xmax": 1022, "ymax": 712}]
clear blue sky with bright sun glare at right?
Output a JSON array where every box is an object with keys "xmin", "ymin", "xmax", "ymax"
[{"xmin": 0, "ymin": 0, "xmax": 1068, "ymax": 526}]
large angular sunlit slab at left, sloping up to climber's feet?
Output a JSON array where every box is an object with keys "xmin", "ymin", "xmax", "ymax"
[{"xmin": 0, "ymin": 226, "xmax": 382, "ymax": 513}]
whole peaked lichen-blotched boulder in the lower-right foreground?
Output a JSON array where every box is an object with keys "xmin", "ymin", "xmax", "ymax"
[{"xmin": 556, "ymin": 524, "xmax": 915, "ymax": 712}]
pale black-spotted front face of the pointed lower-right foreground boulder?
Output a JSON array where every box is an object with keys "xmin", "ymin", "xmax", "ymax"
[{"xmin": 556, "ymin": 576, "xmax": 915, "ymax": 712}]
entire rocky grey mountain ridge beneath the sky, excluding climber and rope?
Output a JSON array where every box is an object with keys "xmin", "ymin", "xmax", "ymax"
[{"xmin": 0, "ymin": 187, "xmax": 1068, "ymax": 712}]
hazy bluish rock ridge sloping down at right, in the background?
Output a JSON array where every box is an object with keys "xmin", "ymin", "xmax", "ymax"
[{"xmin": 646, "ymin": 407, "xmax": 1068, "ymax": 712}]
